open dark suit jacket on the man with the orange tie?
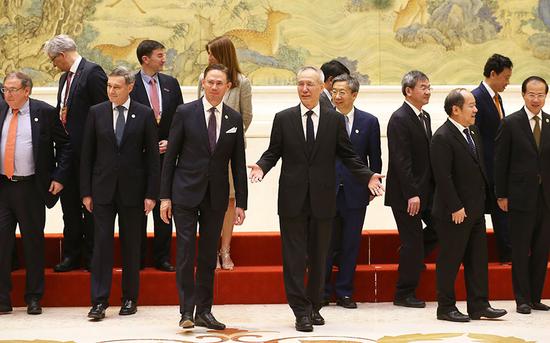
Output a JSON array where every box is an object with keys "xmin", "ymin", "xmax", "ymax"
[{"xmin": 0, "ymin": 99, "xmax": 72, "ymax": 208}]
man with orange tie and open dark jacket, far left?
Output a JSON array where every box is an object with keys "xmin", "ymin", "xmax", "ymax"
[{"xmin": 0, "ymin": 72, "xmax": 71, "ymax": 314}]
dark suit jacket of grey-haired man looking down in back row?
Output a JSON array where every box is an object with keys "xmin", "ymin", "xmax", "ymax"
[{"xmin": 57, "ymin": 58, "xmax": 108, "ymax": 156}]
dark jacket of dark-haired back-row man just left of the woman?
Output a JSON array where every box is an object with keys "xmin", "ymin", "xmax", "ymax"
[{"xmin": 130, "ymin": 71, "xmax": 183, "ymax": 141}]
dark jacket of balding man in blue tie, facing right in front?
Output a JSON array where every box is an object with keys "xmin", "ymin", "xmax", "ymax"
[{"xmin": 431, "ymin": 120, "xmax": 488, "ymax": 221}]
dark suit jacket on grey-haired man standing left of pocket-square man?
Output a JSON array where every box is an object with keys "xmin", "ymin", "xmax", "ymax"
[{"xmin": 80, "ymin": 100, "xmax": 160, "ymax": 206}]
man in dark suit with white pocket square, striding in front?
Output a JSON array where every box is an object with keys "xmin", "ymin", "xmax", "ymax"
[{"xmin": 160, "ymin": 64, "xmax": 248, "ymax": 330}]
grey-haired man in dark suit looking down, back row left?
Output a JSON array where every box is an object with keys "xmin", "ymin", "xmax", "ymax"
[{"xmin": 44, "ymin": 35, "xmax": 107, "ymax": 272}]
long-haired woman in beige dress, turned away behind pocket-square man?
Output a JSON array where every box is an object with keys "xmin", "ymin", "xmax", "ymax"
[{"xmin": 198, "ymin": 36, "xmax": 252, "ymax": 270}]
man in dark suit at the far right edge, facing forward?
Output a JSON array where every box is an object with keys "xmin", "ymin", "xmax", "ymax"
[{"xmin": 495, "ymin": 76, "xmax": 550, "ymax": 314}]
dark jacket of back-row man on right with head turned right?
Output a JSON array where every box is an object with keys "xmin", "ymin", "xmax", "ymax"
[{"xmin": 472, "ymin": 83, "xmax": 505, "ymax": 212}]
